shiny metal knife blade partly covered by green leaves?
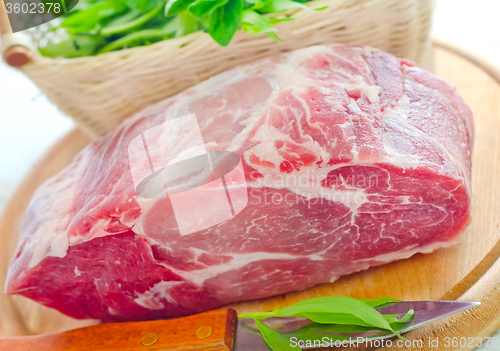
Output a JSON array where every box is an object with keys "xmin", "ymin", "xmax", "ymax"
[{"xmin": 234, "ymin": 301, "xmax": 480, "ymax": 351}]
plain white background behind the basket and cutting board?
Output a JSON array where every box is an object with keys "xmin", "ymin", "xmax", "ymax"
[{"xmin": 0, "ymin": 0, "xmax": 500, "ymax": 350}]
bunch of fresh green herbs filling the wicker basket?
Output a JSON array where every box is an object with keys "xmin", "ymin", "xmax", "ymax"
[{"xmin": 40, "ymin": 0, "xmax": 323, "ymax": 58}]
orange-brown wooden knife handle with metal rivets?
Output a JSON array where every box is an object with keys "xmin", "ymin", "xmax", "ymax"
[{"xmin": 0, "ymin": 309, "xmax": 236, "ymax": 351}]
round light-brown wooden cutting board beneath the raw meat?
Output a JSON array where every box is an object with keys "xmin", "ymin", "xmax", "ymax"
[{"xmin": 0, "ymin": 44, "xmax": 500, "ymax": 350}]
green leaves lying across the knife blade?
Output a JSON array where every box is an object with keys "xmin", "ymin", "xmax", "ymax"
[{"xmin": 238, "ymin": 296, "xmax": 414, "ymax": 351}]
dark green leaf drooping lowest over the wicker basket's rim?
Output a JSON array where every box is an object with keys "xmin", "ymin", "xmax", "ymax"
[{"xmin": 208, "ymin": 0, "xmax": 243, "ymax": 46}]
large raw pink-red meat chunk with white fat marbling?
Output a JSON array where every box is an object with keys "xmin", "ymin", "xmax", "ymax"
[{"xmin": 6, "ymin": 45, "xmax": 473, "ymax": 321}]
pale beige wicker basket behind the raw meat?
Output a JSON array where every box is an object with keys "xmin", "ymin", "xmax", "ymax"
[{"xmin": 1, "ymin": 0, "xmax": 434, "ymax": 137}]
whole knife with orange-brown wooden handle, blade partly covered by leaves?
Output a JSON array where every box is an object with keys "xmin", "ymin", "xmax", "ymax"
[{"xmin": 0, "ymin": 301, "xmax": 479, "ymax": 351}]
